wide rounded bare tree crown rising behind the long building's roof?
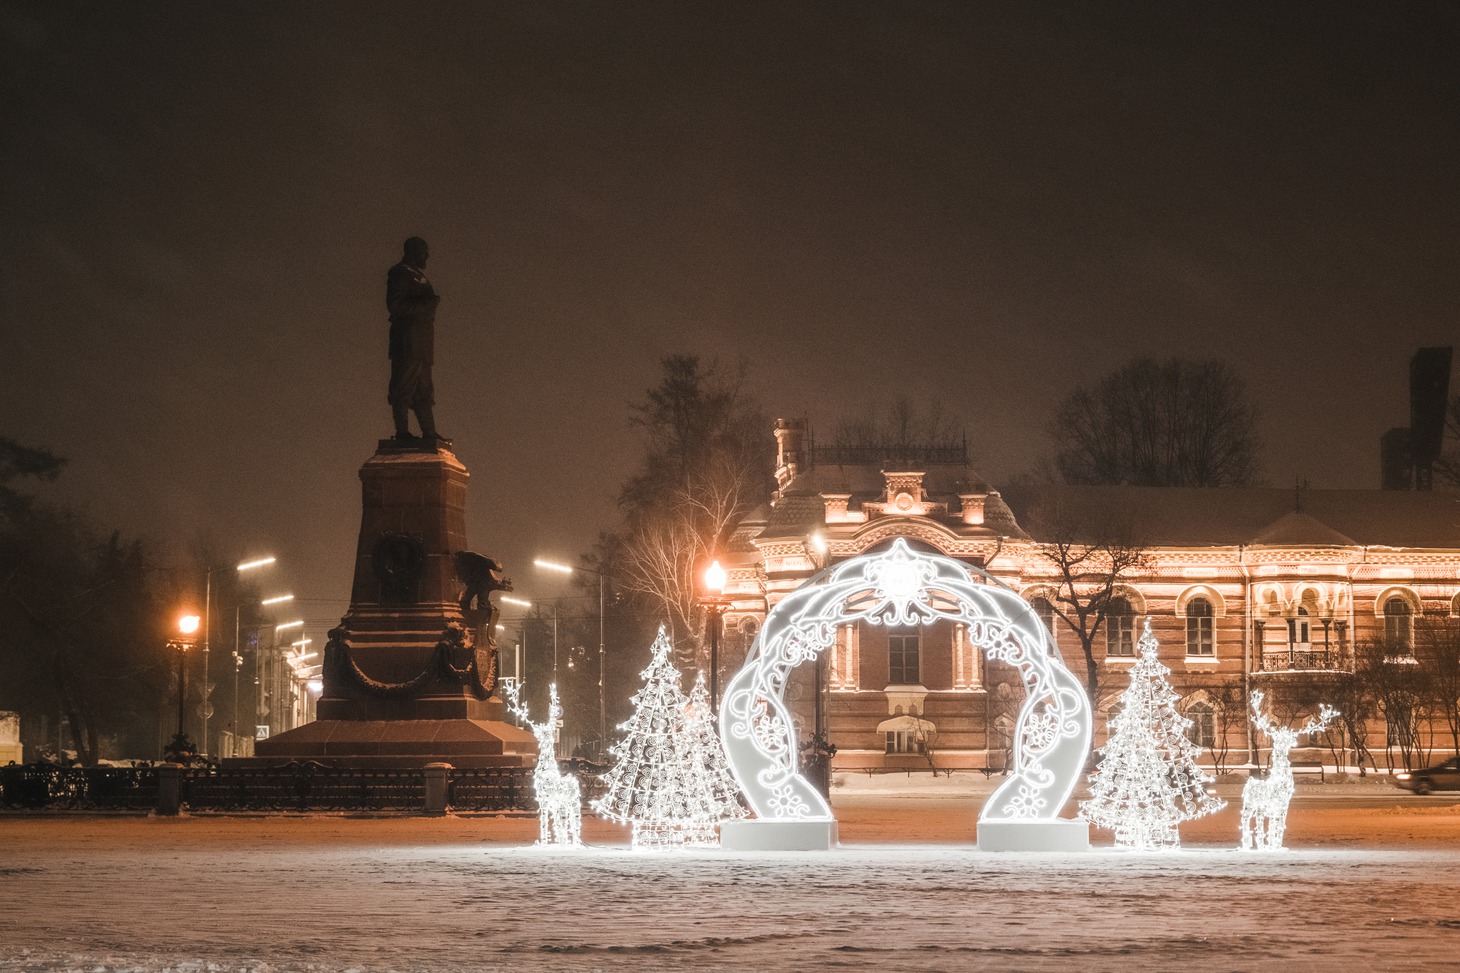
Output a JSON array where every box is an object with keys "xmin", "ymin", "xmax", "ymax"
[{"xmin": 1050, "ymin": 358, "xmax": 1259, "ymax": 487}]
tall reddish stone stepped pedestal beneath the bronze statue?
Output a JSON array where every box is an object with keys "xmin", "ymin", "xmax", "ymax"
[{"xmin": 242, "ymin": 440, "xmax": 537, "ymax": 767}]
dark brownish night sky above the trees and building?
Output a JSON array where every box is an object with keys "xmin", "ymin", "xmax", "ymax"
[{"xmin": 0, "ymin": 0, "xmax": 1460, "ymax": 625}]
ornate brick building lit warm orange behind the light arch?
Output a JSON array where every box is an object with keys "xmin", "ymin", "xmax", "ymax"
[{"xmin": 721, "ymin": 419, "xmax": 1460, "ymax": 768}]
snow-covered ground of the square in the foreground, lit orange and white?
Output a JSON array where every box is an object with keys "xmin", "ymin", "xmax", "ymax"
[{"xmin": 0, "ymin": 777, "xmax": 1460, "ymax": 973}]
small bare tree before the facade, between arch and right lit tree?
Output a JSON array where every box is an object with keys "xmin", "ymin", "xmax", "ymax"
[{"xmin": 1026, "ymin": 497, "xmax": 1148, "ymax": 709}]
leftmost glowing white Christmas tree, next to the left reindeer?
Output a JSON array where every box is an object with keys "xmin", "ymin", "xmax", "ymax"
[{"xmin": 593, "ymin": 625, "xmax": 689, "ymax": 847}]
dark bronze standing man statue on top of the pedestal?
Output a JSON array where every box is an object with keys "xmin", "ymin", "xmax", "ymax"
[{"xmin": 385, "ymin": 237, "xmax": 444, "ymax": 440}]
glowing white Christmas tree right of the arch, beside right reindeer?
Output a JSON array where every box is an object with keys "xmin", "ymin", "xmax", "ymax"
[{"xmin": 1080, "ymin": 618, "xmax": 1225, "ymax": 850}]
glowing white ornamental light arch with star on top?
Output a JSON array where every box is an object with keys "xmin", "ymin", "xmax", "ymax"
[{"xmin": 720, "ymin": 538, "xmax": 1091, "ymax": 850}]
